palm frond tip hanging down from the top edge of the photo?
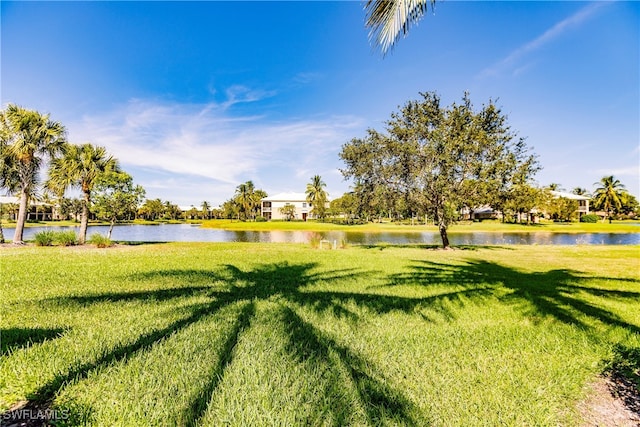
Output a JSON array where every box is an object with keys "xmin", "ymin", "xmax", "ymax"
[{"xmin": 365, "ymin": 0, "xmax": 436, "ymax": 54}]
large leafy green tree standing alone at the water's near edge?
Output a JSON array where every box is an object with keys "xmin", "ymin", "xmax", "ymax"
[{"xmin": 340, "ymin": 93, "xmax": 538, "ymax": 248}]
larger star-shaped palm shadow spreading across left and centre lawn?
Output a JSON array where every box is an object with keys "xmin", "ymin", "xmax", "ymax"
[{"xmin": 6, "ymin": 262, "xmax": 482, "ymax": 424}]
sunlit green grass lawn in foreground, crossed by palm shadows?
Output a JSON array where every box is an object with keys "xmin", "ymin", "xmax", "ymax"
[{"xmin": 0, "ymin": 243, "xmax": 640, "ymax": 426}]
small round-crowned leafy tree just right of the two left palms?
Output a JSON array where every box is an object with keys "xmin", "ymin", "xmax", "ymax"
[{"xmin": 91, "ymin": 171, "xmax": 145, "ymax": 239}]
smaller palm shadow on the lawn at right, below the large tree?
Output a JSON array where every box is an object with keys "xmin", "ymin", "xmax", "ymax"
[{"xmin": 387, "ymin": 260, "xmax": 640, "ymax": 333}]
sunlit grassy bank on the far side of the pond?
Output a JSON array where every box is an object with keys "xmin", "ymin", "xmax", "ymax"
[{"xmin": 202, "ymin": 219, "xmax": 640, "ymax": 234}]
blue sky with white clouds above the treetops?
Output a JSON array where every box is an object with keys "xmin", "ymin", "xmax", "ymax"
[{"xmin": 0, "ymin": 0, "xmax": 640, "ymax": 206}]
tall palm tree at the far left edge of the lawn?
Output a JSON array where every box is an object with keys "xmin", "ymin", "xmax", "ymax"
[{"xmin": 0, "ymin": 104, "xmax": 65, "ymax": 243}]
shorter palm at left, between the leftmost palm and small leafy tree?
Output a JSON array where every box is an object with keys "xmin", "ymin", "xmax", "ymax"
[{"xmin": 47, "ymin": 144, "xmax": 118, "ymax": 244}]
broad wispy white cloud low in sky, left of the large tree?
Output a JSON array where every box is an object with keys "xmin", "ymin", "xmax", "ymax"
[{"xmin": 67, "ymin": 98, "xmax": 363, "ymax": 204}]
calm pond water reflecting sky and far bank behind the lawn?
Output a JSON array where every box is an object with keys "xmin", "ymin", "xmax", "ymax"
[{"xmin": 18, "ymin": 224, "xmax": 640, "ymax": 245}]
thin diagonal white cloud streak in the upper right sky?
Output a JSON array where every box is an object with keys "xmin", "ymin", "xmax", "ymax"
[{"xmin": 479, "ymin": 1, "xmax": 611, "ymax": 78}]
